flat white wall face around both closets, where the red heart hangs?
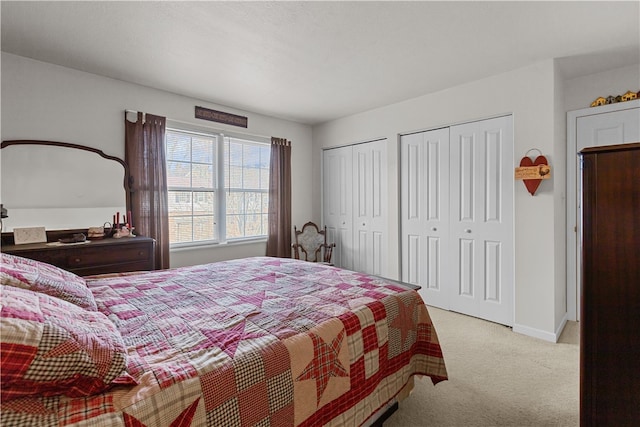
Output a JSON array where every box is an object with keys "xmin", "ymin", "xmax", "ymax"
[{"xmin": 313, "ymin": 60, "xmax": 565, "ymax": 340}]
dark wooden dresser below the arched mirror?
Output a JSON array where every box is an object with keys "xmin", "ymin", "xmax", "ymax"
[{"xmin": 2, "ymin": 236, "xmax": 156, "ymax": 276}]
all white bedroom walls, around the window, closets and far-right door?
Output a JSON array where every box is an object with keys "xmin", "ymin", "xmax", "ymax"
[{"xmin": 1, "ymin": 48, "xmax": 640, "ymax": 339}]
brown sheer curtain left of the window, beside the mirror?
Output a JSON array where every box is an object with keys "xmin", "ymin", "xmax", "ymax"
[{"xmin": 124, "ymin": 111, "xmax": 169, "ymax": 268}]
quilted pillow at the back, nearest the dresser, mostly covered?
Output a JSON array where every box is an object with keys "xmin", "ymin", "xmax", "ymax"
[{"xmin": 0, "ymin": 253, "xmax": 98, "ymax": 311}]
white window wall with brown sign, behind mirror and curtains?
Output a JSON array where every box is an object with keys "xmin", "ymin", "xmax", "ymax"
[{"xmin": 1, "ymin": 52, "xmax": 313, "ymax": 267}]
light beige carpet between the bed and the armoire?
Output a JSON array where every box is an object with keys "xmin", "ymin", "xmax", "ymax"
[{"xmin": 384, "ymin": 307, "xmax": 580, "ymax": 427}]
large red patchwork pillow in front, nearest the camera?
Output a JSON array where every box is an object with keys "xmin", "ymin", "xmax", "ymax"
[{"xmin": 0, "ymin": 286, "xmax": 127, "ymax": 402}]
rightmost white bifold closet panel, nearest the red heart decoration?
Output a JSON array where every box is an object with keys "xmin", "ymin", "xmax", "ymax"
[{"xmin": 450, "ymin": 116, "xmax": 514, "ymax": 325}]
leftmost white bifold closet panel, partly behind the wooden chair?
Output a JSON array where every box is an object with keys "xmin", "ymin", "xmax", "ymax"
[{"xmin": 322, "ymin": 147, "xmax": 353, "ymax": 269}]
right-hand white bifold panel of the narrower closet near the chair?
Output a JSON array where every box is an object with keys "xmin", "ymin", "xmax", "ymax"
[{"xmin": 353, "ymin": 139, "xmax": 388, "ymax": 276}]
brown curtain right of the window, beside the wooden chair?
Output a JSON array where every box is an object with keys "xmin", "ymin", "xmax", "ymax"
[{"xmin": 267, "ymin": 137, "xmax": 291, "ymax": 258}]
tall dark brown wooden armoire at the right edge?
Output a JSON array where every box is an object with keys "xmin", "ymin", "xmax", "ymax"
[{"xmin": 580, "ymin": 143, "xmax": 640, "ymax": 427}]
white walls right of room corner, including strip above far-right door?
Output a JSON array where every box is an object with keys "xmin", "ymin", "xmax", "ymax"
[{"xmin": 313, "ymin": 60, "xmax": 640, "ymax": 340}]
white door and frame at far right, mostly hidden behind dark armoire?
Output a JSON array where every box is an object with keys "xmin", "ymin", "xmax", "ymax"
[{"xmin": 568, "ymin": 108, "xmax": 640, "ymax": 320}]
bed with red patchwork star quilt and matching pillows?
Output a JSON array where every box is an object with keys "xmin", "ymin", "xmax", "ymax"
[{"xmin": 1, "ymin": 254, "xmax": 447, "ymax": 426}]
